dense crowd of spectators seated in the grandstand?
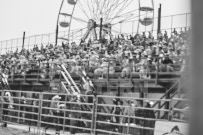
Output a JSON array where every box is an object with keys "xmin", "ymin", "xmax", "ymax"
[{"xmin": 0, "ymin": 28, "xmax": 191, "ymax": 79}]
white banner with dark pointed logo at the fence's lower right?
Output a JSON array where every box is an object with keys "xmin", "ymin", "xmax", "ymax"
[{"xmin": 154, "ymin": 121, "xmax": 188, "ymax": 135}]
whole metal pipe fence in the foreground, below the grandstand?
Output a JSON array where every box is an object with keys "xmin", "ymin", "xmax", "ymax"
[{"xmin": 0, "ymin": 90, "xmax": 189, "ymax": 135}]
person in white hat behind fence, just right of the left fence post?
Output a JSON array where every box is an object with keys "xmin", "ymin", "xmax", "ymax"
[{"xmin": 49, "ymin": 95, "xmax": 61, "ymax": 135}]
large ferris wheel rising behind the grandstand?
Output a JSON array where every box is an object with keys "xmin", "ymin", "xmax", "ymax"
[{"xmin": 56, "ymin": 0, "xmax": 154, "ymax": 43}]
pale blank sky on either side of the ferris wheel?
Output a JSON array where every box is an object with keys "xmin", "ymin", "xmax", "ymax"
[{"xmin": 0, "ymin": 0, "xmax": 191, "ymax": 41}]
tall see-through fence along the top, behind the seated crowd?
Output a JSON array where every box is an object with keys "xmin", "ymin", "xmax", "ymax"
[{"xmin": 0, "ymin": 13, "xmax": 191, "ymax": 54}]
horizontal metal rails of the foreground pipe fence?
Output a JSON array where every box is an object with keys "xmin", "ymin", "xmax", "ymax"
[{"xmin": 0, "ymin": 90, "xmax": 189, "ymax": 134}]
